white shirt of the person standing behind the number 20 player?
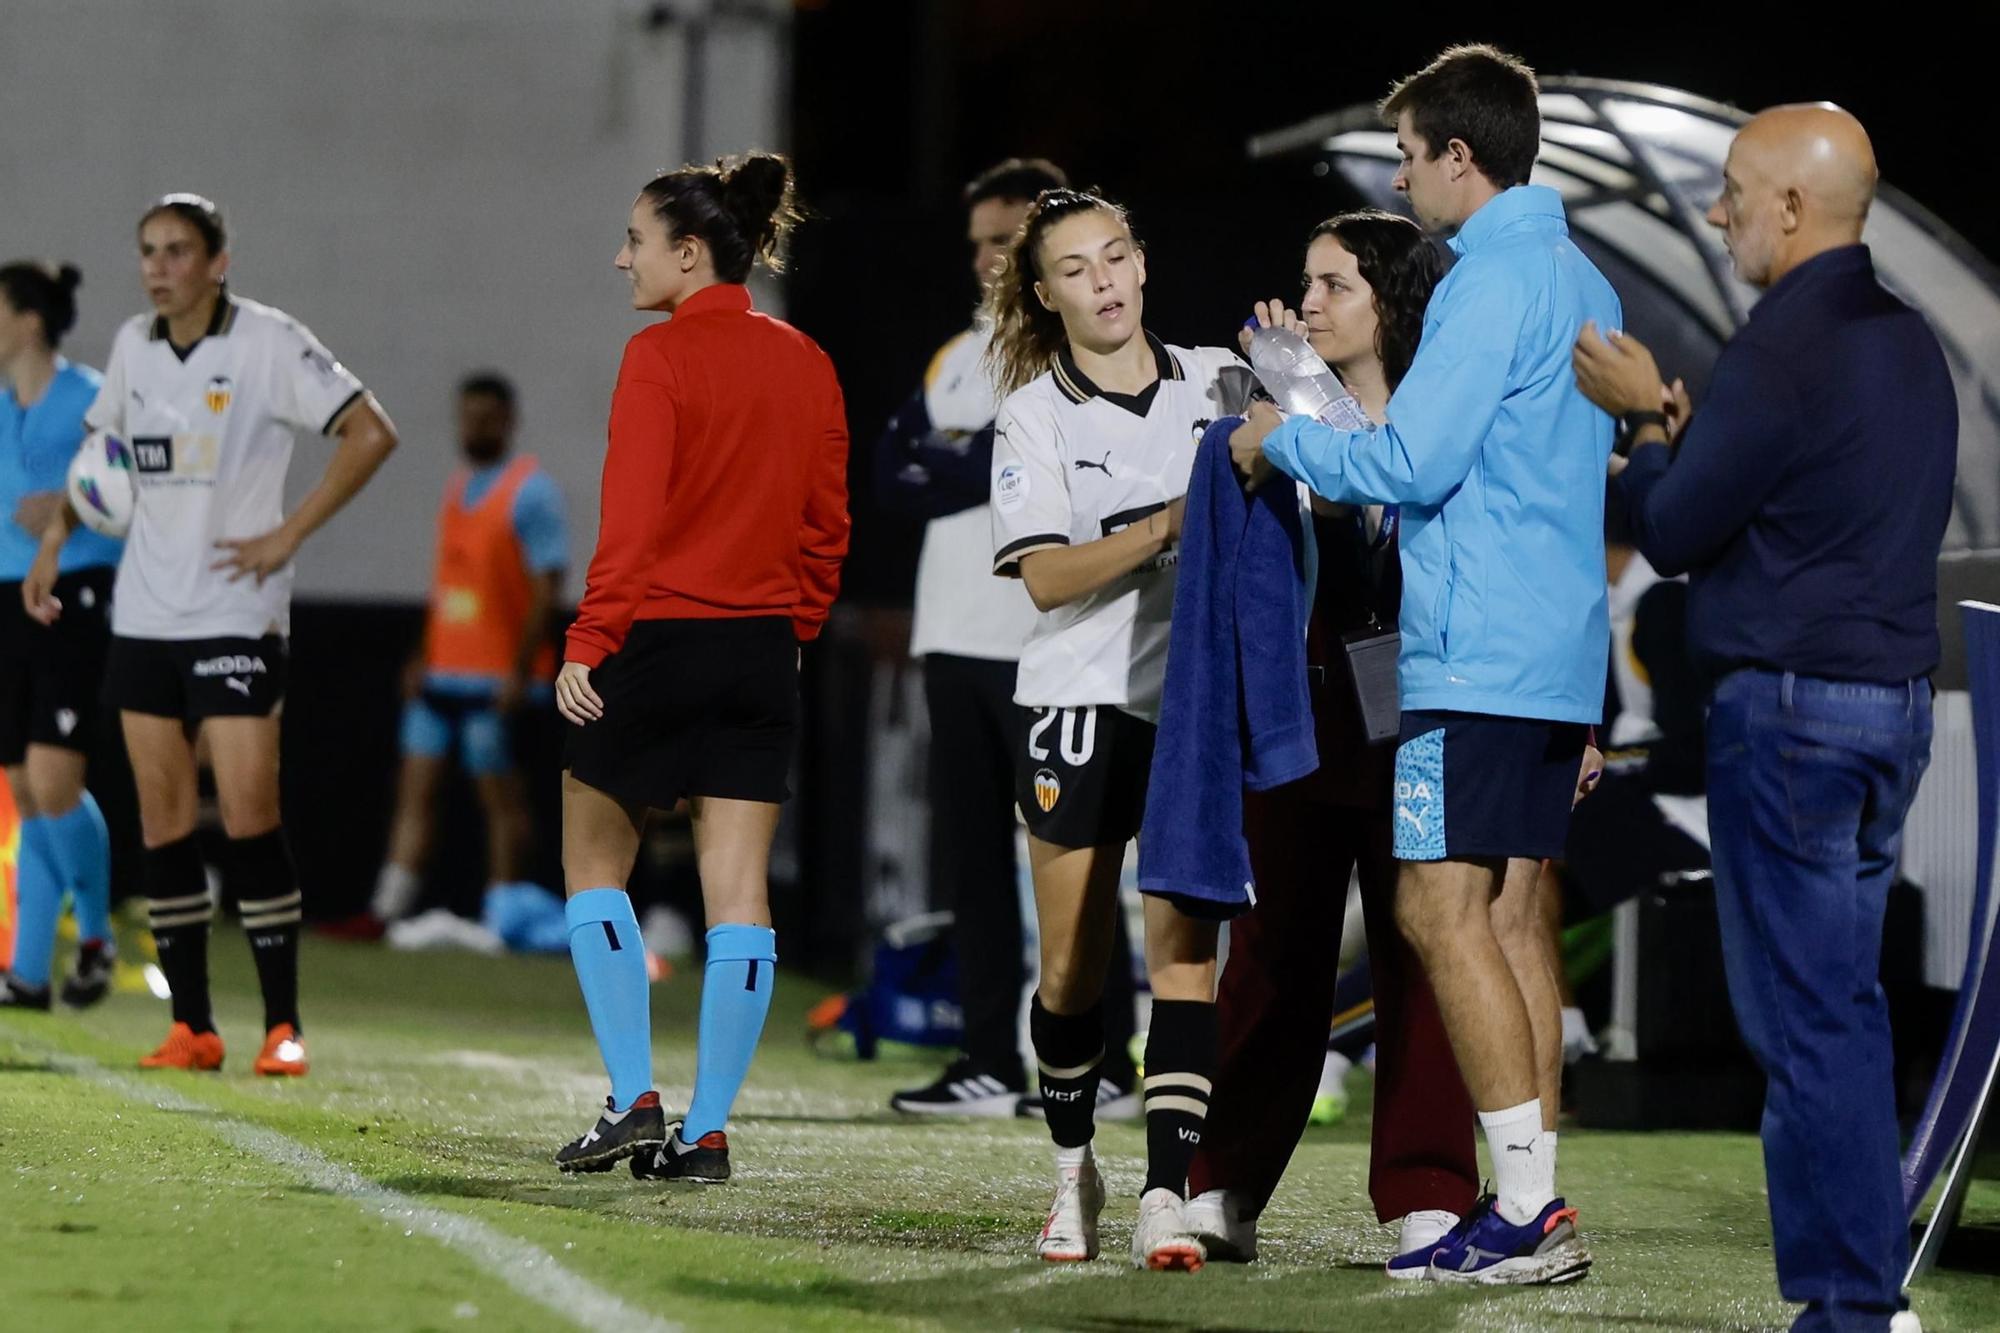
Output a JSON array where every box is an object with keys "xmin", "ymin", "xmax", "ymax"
[{"xmin": 910, "ymin": 324, "xmax": 1034, "ymax": 662}]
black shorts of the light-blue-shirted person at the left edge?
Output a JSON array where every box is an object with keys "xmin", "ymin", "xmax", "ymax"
[{"xmin": 0, "ymin": 564, "xmax": 118, "ymax": 767}]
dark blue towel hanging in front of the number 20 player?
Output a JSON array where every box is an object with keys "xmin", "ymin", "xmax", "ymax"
[{"xmin": 1138, "ymin": 416, "xmax": 1320, "ymax": 917}]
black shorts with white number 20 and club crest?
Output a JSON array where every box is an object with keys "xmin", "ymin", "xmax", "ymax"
[{"xmin": 1014, "ymin": 705, "xmax": 1158, "ymax": 847}]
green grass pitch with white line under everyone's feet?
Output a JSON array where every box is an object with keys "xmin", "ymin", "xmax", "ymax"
[{"xmin": 0, "ymin": 927, "xmax": 2000, "ymax": 1333}]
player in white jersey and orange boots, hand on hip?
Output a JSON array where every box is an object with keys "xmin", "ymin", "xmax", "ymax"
[{"xmin": 22, "ymin": 194, "xmax": 396, "ymax": 1075}]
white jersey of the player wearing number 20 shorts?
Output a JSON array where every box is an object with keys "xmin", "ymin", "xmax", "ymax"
[{"xmin": 990, "ymin": 334, "xmax": 1252, "ymax": 723}]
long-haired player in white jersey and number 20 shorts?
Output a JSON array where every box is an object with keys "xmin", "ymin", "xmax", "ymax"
[{"xmin": 988, "ymin": 190, "xmax": 1250, "ymax": 1271}]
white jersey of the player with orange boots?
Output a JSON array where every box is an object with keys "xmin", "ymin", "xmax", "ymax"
[{"xmin": 84, "ymin": 296, "xmax": 362, "ymax": 638}]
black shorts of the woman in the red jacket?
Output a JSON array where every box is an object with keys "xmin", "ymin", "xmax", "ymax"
[{"xmin": 564, "ymin": 616, "xmax": 798, "ymax": 809}]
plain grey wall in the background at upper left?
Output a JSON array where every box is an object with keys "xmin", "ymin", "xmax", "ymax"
[{"xmin": 0, "ymin": 0, "xmax": 790, "ymax": 600}]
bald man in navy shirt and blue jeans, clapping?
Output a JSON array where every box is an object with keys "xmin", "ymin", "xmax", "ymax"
[{"xmin": 1574, "ymin": 106, "xmax": 1958, "ymax": 1333}]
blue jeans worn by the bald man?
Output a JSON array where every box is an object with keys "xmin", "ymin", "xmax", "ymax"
[{"xmin": 1708, "ymin": 671, "xmax": 1930, "ymax": 1333}]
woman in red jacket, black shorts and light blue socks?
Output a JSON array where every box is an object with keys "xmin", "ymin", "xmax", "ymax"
[{"xmin": 556, "ymin": 152, "xmax": 848, "ymax": 1181}]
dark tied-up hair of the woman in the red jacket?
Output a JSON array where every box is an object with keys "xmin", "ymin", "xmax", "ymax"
[{"xmin": 640, "ymin": 152, "xmax": 804, "ymax": 282}]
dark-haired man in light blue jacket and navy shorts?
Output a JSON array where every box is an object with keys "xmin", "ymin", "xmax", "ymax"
[{"xmin": 1230, "ymin": 46, "xmax": 1620, "ymax": 1283}]
